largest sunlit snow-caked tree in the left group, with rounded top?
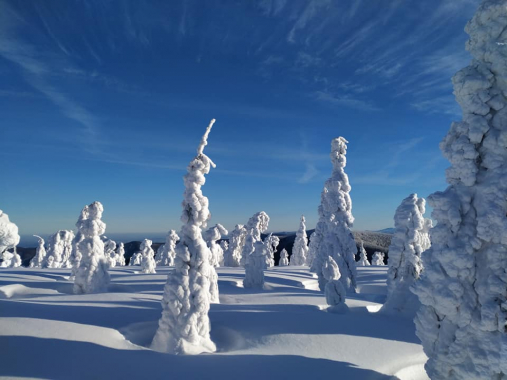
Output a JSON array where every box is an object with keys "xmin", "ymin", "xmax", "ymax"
[{"xmin": 74, "ymin": 202, "xmax": 110, "ymax": 294}]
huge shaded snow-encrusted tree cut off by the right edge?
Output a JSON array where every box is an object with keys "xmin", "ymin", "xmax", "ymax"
[{"xmin": 413, "ymin": 0, "xmax": 507, "ymax": 379}]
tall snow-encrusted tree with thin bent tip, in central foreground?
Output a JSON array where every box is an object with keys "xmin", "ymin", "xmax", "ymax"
[{"xmin": 151, "ymin": 119, "xmax": 220, "ymax": 354}]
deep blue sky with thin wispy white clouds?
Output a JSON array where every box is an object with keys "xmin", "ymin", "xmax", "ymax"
[{"xmin": 0, "ymin": 0, "xmax": 479, "ymax": 239}]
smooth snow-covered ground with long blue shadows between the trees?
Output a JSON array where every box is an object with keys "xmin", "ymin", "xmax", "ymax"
[{"xmin": 0, "ymin": 267, "xmax": 427, "ymax": 380}]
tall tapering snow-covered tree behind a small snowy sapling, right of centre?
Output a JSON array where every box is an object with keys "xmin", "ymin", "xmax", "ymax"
[{"xmin": 312, "ymin": 137, "xmax": 357, "ymax": 293}]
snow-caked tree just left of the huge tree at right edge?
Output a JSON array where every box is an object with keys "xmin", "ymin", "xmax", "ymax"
[{"xmin": 382, "ymin": 194, "xmax": 431, "ymax": 314}]
